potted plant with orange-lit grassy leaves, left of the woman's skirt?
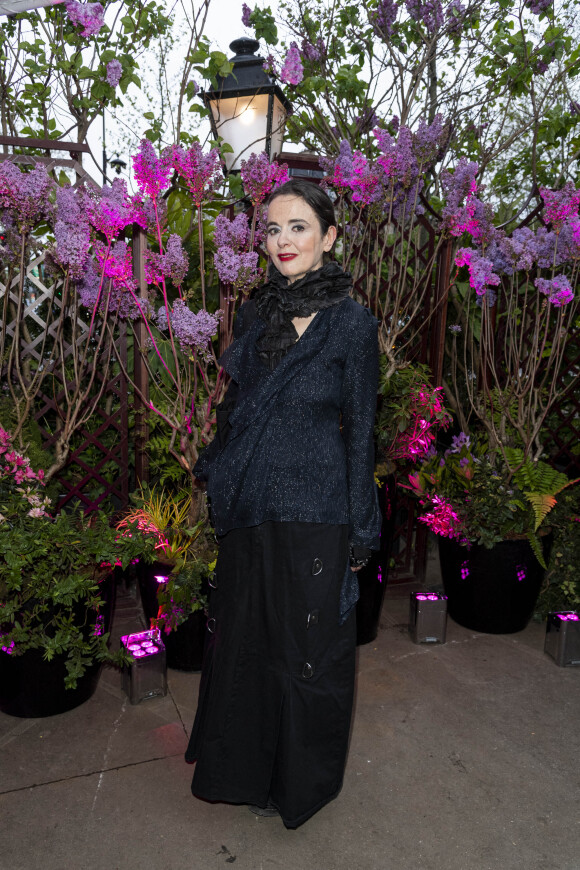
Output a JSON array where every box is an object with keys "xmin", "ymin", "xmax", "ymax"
[{"xmin": 118, "ymin": 486, "xmax": 217, "ymax": 671}]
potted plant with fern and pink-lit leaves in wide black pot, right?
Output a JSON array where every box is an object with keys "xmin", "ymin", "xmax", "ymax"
[{"xmin": 409, "ymin": 432, "xmax": 571, "ymax": 633}]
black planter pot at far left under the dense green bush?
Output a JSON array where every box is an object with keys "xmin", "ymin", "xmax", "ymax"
[{"xmin": 0, "ymin": 574, "xmax": 115, "ymax": 719}]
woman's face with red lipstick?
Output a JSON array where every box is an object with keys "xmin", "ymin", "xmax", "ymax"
[{"xmin": 266, "ymin": 196, "xmax": 336, "ymax": 284}]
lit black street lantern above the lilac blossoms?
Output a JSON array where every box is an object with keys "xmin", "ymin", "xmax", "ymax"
[{"xmin": 201, "ymin": 37, "xmax": 292, "ymax": 172}]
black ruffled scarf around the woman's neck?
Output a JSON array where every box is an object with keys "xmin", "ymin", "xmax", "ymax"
[{"xmin": 254, "ymin": 262, "xmax": 352, "ymax": 369}]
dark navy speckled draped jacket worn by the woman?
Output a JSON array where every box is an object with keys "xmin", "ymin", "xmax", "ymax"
[{"xmin": 195, "ymin": 297, "xmax": 381, "ymax": 549}]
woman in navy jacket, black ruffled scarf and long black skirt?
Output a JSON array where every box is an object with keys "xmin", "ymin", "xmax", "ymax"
[{"xmin": 186, "ymin": 180, "xmax": 380, "ymax": 828}]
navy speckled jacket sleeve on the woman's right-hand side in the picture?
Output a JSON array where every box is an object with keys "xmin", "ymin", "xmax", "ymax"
[{"xmin": 341, "ymin": 308, "xmax": 381, "ymax": 550}]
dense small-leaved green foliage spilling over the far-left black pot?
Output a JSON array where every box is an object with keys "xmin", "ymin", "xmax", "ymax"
[{"xmin": 0, "ymin": 508, "xmax": 147, "ymax": 688}]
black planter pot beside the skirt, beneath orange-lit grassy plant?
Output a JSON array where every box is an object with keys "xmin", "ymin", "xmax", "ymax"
[{"xmin": 137, "ymin": 562, "xmax": 207, "ymax": 671}]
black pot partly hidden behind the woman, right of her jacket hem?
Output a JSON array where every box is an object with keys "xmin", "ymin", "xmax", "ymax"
[{"xmin": 356, "ymin": 474, "xmax": 397, "ymax": 646}]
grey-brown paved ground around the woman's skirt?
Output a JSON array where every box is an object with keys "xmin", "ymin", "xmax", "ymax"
[{"xmin": 0, "ymin": 560, "xmax": 580, "ymax": 870}]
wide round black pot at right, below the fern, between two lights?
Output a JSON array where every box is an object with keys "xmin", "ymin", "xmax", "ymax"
[{"xmin": 439, "ymin": 535, "xmax": 552, "ymax": 634}]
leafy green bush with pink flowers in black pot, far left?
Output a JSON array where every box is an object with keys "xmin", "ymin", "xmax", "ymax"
[{"xmin": 0, "ymin": 428, "xmax": 144, "ymax": 717}]
